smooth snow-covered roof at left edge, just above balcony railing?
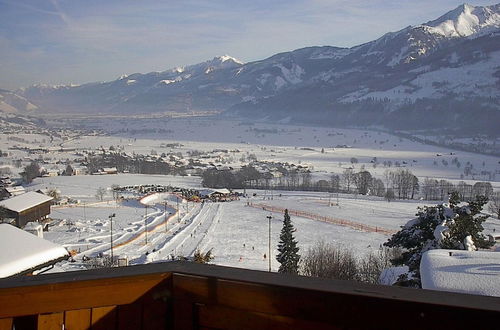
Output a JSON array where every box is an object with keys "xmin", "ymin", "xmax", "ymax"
[{"xmin": 0, "ymin": 224, "xmax": 69, "ymax": 278}]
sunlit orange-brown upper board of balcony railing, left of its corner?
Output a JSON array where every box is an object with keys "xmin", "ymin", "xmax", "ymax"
[{"xmin": 0, "ymin": 273, "xmax": 170, "ymax": 318}]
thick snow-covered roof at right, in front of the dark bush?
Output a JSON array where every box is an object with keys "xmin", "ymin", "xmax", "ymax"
[{"xmin": 420, "ymin": 250, "xmax": 500, "ymax": 297}]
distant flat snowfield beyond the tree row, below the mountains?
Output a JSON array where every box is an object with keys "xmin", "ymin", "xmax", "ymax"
[{"xmin": 50, "ymin": 117, "xmax": 500, "ymax": 184}]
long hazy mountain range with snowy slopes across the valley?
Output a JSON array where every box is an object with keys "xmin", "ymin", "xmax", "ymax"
[{"xmin": 14, "ymin": 4, "xmax": 500, "ymax": 130}]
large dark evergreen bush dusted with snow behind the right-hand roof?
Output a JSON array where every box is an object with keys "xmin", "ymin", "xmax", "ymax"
[{"xmin": 384, "ymin": 193, "xmax": 493, "ymax": 287}]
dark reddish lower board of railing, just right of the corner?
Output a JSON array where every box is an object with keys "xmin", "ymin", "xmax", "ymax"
[{"xmin": 196, "ymin": 304, "xmax": 339, "ymax": 330}]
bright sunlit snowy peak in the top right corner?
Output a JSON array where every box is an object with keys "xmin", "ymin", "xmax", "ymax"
[{"xmin": 422, "ymin": 4, "xmax": 500, "ymax": 38}]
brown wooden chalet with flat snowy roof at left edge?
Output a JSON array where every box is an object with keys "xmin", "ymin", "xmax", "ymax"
[{"xmin": 0, "ymin": 191, "xmax": 53, "ymax": 228}]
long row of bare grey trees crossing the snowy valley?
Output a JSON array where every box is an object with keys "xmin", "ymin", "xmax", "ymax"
[{"xmin": 202, "ymin": 166, "xmax": 493, "ymax": 205}]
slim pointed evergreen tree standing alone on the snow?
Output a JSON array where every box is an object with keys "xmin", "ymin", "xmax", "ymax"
[{"xmin": 276, "ymin": 210, "xmax": 300, "ymax": 274}]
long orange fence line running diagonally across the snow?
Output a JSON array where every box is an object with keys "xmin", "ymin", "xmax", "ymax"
[{"xmin": 248, "ymin": 202, "xmax": 397, "ymax": 235}]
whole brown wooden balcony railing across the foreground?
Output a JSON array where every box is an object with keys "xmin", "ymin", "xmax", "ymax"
[{"xmin": 0, "ymin": 262, "xmax": 500, "ymax": 330}]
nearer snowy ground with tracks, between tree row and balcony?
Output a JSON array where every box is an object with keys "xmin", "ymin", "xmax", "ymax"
[{"xmin": 30, "ymin": 174, "xmax": 500, "ymax": 270}]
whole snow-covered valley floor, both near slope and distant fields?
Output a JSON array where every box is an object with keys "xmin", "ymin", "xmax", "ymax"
[{"xmin": 0, "ymin": 118, "xmax": 500, "ymax": 270}]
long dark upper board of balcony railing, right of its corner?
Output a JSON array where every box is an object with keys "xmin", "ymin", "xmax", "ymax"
[{"xmin": 173, "ymin": 274, "xmax": 500, "ymax": 329}]
